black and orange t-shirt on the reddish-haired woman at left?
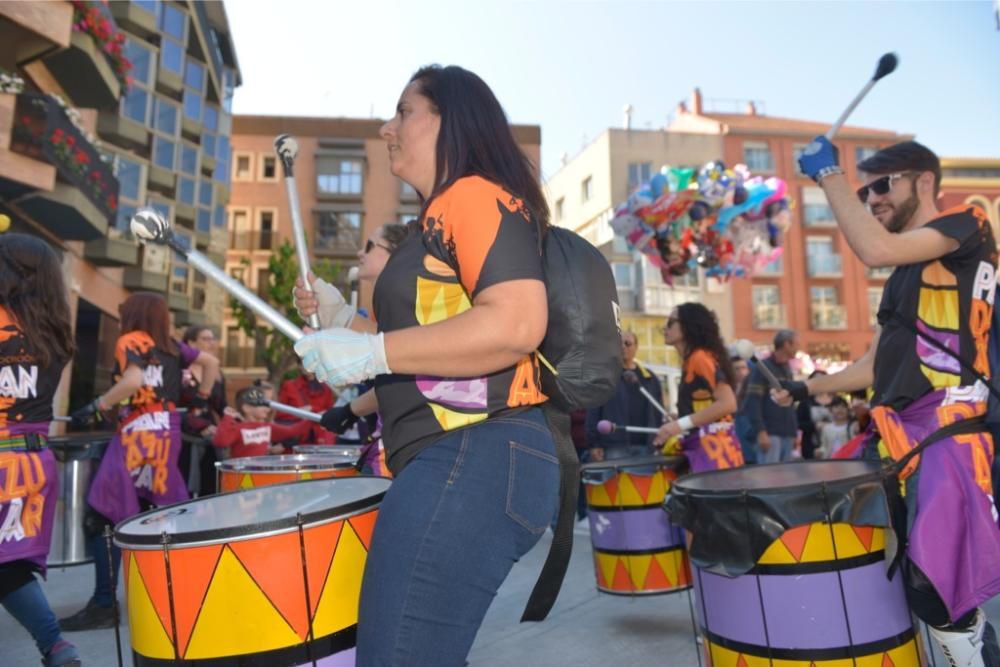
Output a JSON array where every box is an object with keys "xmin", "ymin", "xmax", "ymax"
[{"xmin": 111, "ymin": 331, "xmax": 198, "ymax": 423}]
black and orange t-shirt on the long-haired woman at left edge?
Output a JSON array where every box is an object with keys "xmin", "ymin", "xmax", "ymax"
[{"xmin": 0, "ymin": 306, "xmax": 68, "ymax": 439}]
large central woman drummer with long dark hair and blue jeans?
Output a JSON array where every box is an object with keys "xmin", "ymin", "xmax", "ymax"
[{"xmin": 296, "ymin": 66, "xmax": 559, "ymax": 666}]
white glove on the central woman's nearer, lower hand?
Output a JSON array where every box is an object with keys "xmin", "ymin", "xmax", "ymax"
[{"xmin": 295, "ymin": 329, "xmax": 392, "ymax": 387}]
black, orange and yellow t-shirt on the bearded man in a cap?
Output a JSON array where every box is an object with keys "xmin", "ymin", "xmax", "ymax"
[{"xmin": 873, "ymin": 204, "xmax": 997, "ymax": 410}]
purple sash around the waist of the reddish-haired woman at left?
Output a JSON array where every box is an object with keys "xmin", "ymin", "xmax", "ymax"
[{"xmin": 87, "ymin": 411, "xmax": 188, "ymax": 523}]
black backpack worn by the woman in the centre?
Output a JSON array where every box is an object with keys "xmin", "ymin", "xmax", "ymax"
[{"xmin": 538, "ymin": 227, "xmax": 622, "ymax": 412}]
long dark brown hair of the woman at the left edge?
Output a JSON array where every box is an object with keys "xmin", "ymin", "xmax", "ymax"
[{"xmin": 0, "ymin": 233, "xmax": 76, "ymax": 366}]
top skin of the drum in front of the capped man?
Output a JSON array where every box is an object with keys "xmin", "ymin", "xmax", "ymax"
[{"xmin": 676, "ymin": 460, "xmax": 882, "ymax": 496}]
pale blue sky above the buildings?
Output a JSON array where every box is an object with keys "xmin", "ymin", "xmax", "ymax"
[{"xmin": 226, "ymin": 0, "xmax": 1000, "ymax": 183}]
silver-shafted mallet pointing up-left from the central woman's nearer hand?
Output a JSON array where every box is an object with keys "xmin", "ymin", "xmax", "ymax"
[{"xmin": 129, "ymin": 208, "xmax": 305, "ymax": 342}]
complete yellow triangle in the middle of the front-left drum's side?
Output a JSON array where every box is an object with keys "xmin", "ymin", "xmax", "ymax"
[{"xmin": 183, "ymin": 547, "xmax": 302, "ymax": 660}]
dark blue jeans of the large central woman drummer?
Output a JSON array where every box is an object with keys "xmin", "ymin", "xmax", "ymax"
[{"xmin": 357, "ymin": 408, "xmax": 559, "ymax": 667}]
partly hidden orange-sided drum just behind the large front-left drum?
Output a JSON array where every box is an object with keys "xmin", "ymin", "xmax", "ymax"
[{"xmin": 215, "ymin": 453, "xmax": 358, "ymax": 492}]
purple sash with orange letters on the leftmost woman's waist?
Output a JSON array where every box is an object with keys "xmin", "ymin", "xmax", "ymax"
[{"xmin": 0, "ymin": 449, "xmax": 59, "ymax": 575}]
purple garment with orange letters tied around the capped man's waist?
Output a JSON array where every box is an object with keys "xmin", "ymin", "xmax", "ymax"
[{"xmin": 873, "ymin": 390, "xmax": 1000, "ymax": 621}]
